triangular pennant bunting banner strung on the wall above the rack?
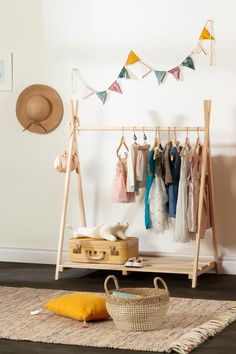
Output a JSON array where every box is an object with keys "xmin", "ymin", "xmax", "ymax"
[{"xmin": 71, "ymin": 20, "xmax": 215, "ymax": 104}]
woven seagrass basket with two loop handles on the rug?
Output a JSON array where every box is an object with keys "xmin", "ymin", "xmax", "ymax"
[{"xmin": 104, "ymin": 275, "xmax": 170, "ymax": 331}]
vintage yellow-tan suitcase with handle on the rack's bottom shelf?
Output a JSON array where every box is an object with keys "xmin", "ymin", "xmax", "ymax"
[{"xmin": 69, "ymin": 237, "xmax": 138, "ymax": 264}]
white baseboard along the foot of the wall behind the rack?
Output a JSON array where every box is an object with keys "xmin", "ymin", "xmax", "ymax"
[{"xmin": 0, "ymin": 247, "xmax": 236, "ymax": 274}]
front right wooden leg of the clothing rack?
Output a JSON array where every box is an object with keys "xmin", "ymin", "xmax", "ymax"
[{"xmin": 192, "ymin": 100, "xmax": 211, "ymax": 288}]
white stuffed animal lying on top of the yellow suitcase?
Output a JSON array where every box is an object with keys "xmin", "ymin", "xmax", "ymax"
[{"xmin": 73, "ymin": 222, "xmax": 129, "ymax": 241}]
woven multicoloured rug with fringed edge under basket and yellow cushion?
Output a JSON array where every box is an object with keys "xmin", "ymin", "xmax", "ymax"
[{"xmin": 0, "ymin": 287, "xmax": 236, "ymax": 353}]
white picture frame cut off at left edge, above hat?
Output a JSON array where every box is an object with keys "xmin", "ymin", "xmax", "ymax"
[{"xmin": 0, "ymin": 53, "xmax": 13, "ymax": 91}]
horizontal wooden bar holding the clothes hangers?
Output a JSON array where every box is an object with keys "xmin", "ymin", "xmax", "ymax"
[{"xmin": 76, "ymin": 126, "xmax": 206, "ymax": 132}]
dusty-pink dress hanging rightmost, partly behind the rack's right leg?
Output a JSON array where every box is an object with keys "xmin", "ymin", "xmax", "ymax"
[{"xmin": 187, "ymin": 145, "xmax": 211, "ymax": 238}]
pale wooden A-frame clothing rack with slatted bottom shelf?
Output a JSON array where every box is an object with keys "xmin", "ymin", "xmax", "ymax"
[{"xmin": 55, "ymin": 100, "xmax": 219, "ymax": 288}]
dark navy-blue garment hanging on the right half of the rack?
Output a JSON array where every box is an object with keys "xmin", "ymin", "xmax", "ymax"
[{"xmin": 168, "ymin": 146, "xmax": 181, "ymax": 218}]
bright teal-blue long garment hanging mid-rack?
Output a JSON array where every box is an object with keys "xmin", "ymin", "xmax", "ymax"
[{"xmin": 144, "ymin": 149, "xmax": 156, "ymax": 229}]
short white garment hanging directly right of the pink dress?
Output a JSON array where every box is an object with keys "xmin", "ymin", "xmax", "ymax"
[{"xmin": 126, "ymin": 144, "xmax": 140, "ymax": 192}]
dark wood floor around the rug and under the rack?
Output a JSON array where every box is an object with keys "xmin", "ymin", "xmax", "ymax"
[{"xmin": 0, "ymin": 262, "xmax": 236, "ymax": 354}]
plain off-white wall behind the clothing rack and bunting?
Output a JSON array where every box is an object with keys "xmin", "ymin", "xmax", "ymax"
[{"xmin": 0, "ymin": 0, "xmax": 236, "ymax": 272}]
